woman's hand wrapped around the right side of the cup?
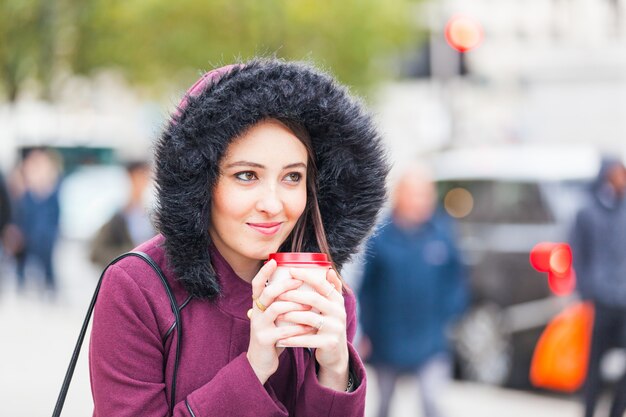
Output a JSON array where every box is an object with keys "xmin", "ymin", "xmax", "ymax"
[{"xmin": 278, "ymin": 268, "xmax": 349, "ymax": 391}]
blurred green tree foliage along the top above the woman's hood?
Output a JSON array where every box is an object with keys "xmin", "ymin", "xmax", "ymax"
[{"xmin": 0, "ymin": 0, "xmax": 418, "ymax": 101}]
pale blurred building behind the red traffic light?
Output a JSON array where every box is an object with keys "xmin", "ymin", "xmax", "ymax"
[{"xmin": 379, "ymin": 0, "xmax": 626, "ymax": 170}]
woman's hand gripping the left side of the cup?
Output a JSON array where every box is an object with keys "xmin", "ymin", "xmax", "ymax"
[{"xmin": 247, "ymin": 260, "xmax": 311, "ymax": 384}]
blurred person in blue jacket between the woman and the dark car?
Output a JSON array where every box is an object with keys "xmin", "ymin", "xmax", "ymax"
[{"xmin": 359, "ymin": 166, "xmax": 467, "ymax": 417}]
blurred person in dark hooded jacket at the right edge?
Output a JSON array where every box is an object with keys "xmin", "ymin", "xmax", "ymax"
[{"xmin": 570, "ymin": 158, "xmax": 626, "ymax": 417}]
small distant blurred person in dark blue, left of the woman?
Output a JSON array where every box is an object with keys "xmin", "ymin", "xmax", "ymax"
[{"xmin": 15, "ymin": 149, "xmax": 61, "ymax": 294}]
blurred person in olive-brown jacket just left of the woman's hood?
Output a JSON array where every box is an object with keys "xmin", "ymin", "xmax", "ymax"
[{"xmin": 90, "ymin": 161, "xmax": 156, "ymax": 268}]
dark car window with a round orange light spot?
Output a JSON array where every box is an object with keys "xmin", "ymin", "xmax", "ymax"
[{"xmin": 438, "ymin": 180, "xmax": 554, "ymax": 224}]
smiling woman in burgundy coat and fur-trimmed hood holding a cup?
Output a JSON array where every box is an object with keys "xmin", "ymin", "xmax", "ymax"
[{"xmin": 90, "ymin": 60, "xmax": 387, "ymax": 417}]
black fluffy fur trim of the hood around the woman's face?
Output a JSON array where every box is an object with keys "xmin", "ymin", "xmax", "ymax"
[{"xmin": 155, "ymin": 59, "xmax": 388, "ymax": 298}]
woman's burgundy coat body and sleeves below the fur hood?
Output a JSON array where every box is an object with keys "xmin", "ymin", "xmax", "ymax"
[{"xmin": 89, "ymin": 235, "xmax": 366, "ymax": 417}]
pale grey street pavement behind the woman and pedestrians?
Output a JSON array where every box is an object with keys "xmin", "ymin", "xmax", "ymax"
[{"xmin": 0, "ymin": 237, "xmax": 582, "ymax": 417}]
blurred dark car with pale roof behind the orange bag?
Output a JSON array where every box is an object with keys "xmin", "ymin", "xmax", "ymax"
[{"xmin": 434, "ymin": 146, "xmax": 600, "ymax": 388}]
